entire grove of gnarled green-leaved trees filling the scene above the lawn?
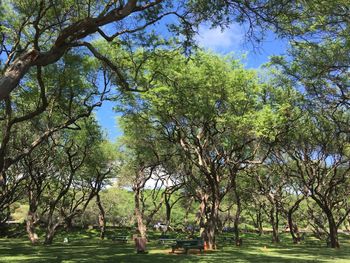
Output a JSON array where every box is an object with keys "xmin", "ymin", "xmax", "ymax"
[{"xmin": 0, "ymin": 0, "xmax": 350, "ymax": 252}]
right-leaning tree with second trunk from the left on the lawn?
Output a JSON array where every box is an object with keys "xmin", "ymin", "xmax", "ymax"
[{"xmin": 31, "ymin": 118, "xmax": 110, "ymax": 244}]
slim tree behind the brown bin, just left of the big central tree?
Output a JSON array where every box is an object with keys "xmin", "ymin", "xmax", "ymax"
[{"xmin": 120, "ymin": 116, "xmax": 167, "ymax": 238}]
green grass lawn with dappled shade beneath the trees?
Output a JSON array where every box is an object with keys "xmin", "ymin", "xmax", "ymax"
[{"xmin": 0, "ymin": 233, "xmax": 350, "ymax": 263}]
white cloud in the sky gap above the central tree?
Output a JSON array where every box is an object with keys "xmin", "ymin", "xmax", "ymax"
[{"xmin": 196, "ymin": 24, "xmax": 244, "ymax": 53}]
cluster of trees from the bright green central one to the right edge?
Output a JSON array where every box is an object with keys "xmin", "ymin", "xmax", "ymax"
[{"xmin": 115, "ymin": 50, "xmax": 350, "ymax": 248}]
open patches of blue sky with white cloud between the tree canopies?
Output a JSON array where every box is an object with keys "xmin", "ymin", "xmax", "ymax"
[{"xmin": 96, "ymin": 24, "xmax": 287, "ymax": 142}]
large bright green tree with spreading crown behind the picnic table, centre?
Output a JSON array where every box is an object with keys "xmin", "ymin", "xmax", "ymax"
[{"xmin": 118, "ymin": 50, "xmax": 296, "ymax": 248}]
